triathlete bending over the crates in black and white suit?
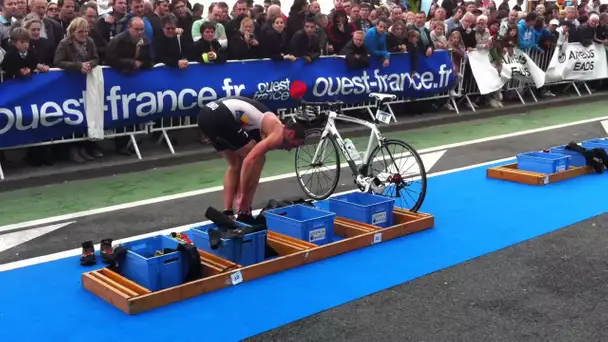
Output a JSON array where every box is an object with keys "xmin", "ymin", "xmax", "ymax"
[{"xmin": 198, "ymin": 96, "xmax": 305, "ymax": 223}]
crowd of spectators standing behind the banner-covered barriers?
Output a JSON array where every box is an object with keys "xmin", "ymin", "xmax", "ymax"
[{"xmin": 0, "ymin": 0, "xmax": 608, "ymax": 164}]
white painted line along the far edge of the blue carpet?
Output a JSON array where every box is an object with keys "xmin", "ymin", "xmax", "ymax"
[{"xmin": 0, "ymin": 157, "xmax": 514, "ymax": 272}]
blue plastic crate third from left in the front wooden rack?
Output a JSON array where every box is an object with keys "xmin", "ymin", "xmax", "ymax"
[{"xmin": 264, "ymin": 204, "xmax": 336, "ymax": 245}]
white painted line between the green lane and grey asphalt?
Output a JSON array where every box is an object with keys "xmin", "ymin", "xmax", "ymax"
[{"xmin": 0, "ymin": 116, "xmax": 608, "ymax": 234}]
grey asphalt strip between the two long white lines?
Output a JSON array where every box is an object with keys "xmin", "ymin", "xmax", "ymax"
[{"xmin": 0, "ymin": 123, "xmax": 605, "ymax": 264}]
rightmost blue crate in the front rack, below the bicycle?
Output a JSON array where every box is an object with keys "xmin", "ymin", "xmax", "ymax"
[{"xmin": 329, "ymin": 192, "xmax": 395, "ymax": 228}]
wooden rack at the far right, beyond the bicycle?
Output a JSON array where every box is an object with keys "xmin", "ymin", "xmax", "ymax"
[{"xmin": 487, "ymin": 163, "xmax": 593, "ymax": 185}]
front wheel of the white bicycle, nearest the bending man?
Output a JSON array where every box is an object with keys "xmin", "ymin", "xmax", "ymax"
[{"xmin": 295, "ymin": 129, "xmax": 340, "ymax": 200}]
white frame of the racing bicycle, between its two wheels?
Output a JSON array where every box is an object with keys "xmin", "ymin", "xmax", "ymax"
[{"xmin": 312, "ymin": 110, "xmax": 384, "ymax": 175}]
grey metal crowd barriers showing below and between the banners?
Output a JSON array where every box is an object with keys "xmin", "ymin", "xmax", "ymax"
[{"xmin": 0, "ymin": 49, "xmax": 591, "ymax": 180}]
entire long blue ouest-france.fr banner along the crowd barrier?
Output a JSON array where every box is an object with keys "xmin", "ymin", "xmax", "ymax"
[{"xmin": 0, "ymin": 51, "xmax": 454, "ymax": 148}]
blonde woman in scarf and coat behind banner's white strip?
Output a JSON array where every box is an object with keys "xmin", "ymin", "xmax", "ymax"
[{"xmin": 53, "ymin": 17, "xmax": 103, "ymax": 163}]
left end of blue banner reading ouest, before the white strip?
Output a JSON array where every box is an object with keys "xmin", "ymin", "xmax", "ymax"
[{"xmin": 0, "ymin": 71, "xmax": 87, "ymax": 148}]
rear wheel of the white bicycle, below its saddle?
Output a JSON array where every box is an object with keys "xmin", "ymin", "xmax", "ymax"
[{"xmin": 367, "ymin": 139, "xmax": 426, "ymax": 212}]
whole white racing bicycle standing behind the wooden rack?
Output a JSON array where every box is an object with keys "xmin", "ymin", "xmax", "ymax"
[{"xmin": 295, "ymin": 93, "xmax": 426, "ymax": 212}]
